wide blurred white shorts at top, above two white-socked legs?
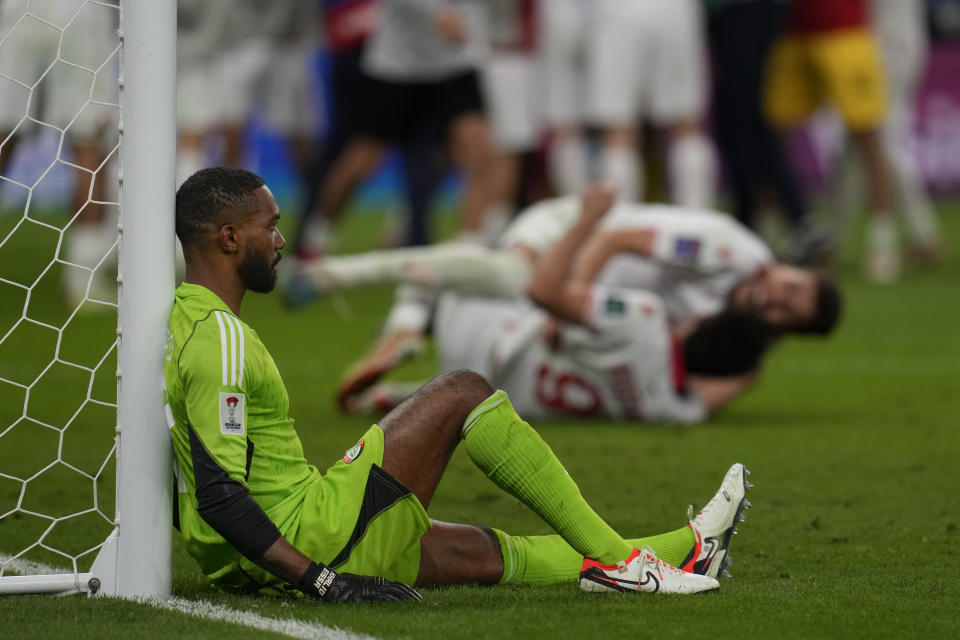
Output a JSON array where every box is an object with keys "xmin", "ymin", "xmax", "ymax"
[{"xmin": 586, "ymin": 0, "xmax": 707, "ymax": 127}]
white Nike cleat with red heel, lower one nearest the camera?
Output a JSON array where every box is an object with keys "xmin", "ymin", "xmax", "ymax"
[{"xmin": 580, "ymin": 547, "xmax": 720, "ymax": 593}]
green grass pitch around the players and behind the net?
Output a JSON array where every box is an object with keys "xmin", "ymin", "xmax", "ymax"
[{"xmin": 0, "ymin": 204, "xmax": 960, "ymax": 639}]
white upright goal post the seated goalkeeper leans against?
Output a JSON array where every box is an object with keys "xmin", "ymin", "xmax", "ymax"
[{"xmin": 111, "ymin": 0, "xmax": 177, "ymax": 596}]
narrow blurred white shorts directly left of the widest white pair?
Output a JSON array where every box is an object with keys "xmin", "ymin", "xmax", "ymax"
[{"xmin": 538, "ymin": 0, "xmax": 589, "ymax": 126}]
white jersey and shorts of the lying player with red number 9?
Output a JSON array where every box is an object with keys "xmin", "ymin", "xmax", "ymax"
[{"xmin": 435, "ymin": 286, "xmax": 707, "ymax": 423}]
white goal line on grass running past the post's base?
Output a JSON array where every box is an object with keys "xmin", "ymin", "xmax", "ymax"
[{"xmin": 0, "ymin": 553, "xmax": 376, "ymax": 640}]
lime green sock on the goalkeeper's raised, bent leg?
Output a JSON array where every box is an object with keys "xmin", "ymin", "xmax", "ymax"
[{"xmin": 462, "ymin": 391, "xmax": 633, "ymax": 569}]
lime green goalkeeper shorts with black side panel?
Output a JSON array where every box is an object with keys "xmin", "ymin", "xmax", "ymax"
[{"xmin": 290, "ymin": 425, "xmax": 430, "ymax": 585}]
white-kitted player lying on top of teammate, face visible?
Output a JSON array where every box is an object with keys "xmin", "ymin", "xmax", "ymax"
[{"xmin": 284, "ymin": 188, "xmax": 841, "ymax": 400}]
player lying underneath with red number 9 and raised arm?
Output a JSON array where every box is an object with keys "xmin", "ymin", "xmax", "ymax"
[{"xmin": 339, "ymin": 189, "xmax": 769, "ymax": 423}]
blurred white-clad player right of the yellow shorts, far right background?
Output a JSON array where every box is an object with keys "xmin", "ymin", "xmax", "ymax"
[{"xmin": 839, "ymin": 0, "xmax": 942, "ymax": 264}]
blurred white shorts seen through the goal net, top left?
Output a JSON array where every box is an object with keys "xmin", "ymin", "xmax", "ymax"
[{"xmin": 0, "ymin": 0, "xmax": 119, "ymax": 139}]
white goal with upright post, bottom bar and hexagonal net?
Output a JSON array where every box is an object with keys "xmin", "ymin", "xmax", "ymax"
[{"xmin": 0, "ymin": 0, "xmax": 177, "ymax": 597}]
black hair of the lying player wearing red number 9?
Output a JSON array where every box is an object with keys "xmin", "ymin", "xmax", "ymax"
[{"xmin": 683, "ymin": 309, "xmax": 775, "ymax": 377}]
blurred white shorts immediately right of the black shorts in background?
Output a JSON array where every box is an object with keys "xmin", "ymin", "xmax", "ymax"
[{"xmin": 482, "ymin": 52, "xmax": 542, "ymax": 152}]
